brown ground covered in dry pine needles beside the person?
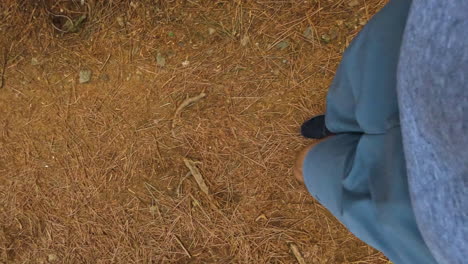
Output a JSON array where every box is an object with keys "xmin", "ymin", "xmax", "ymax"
[{"xmin": 0, "ymin": 0, "xmax": 388, "ymax": 263}]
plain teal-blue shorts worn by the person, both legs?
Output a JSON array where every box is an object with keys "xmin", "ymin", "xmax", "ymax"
[{"xmin": 303, "ymin": 0, "xmax": 437, "ymax": 264}]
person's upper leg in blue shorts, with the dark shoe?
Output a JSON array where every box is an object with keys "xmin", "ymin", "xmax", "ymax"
[{"xmin": 301, "ymin": 0, "xmax": 411, "ymax": 138}]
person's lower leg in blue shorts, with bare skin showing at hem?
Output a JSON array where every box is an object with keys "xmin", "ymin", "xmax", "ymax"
[{"xmin": 296, "ymin": 130, "xmax": 436, "ymax": 264}]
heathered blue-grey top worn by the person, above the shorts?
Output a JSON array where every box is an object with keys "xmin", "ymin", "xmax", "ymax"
[{"xmin": 398, "ymin": 0, "xmax": 468, "ymax": 264}]
